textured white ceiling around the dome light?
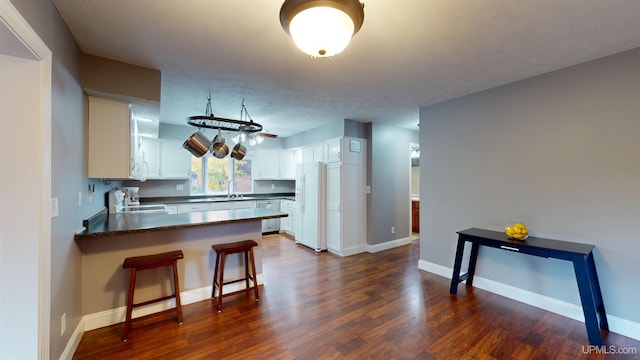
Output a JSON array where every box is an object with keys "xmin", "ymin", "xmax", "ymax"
[{"xmin": 54, "ymin": 0, "xmax": 640, "ymax": 136}]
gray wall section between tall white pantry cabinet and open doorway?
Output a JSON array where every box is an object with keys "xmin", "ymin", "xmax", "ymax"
[{"xmin": 367, "ymin": 123, "xmax": 419, "ymax": 245}]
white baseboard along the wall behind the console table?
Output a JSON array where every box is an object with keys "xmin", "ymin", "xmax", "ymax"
[{"xmin": 418, "ymin": 260, "xmax": 640, "ymax": 340}]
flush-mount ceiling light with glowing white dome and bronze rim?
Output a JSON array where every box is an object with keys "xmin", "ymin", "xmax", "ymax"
[{"xmin": 280, "ymin": 0, "xmax": 364, "ymax": 57}]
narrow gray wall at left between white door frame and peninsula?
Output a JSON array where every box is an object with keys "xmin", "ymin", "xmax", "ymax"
[{"xmin": 11, "ymin": 0, "xmax": 115, "ymax": 359}]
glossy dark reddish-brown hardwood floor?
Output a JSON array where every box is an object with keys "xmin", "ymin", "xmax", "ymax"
[{"xmin": 74, "ymin": 235, "xmax": 640, "ymax": 360}]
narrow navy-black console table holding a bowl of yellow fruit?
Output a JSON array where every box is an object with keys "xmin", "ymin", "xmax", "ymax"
[{"xmin": 449, "ymin": 228, "xmax": 609, "ymax": 346}]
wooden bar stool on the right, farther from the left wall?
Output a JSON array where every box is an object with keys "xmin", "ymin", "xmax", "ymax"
[{"xmin": 211, "ymin": 240, "xmax": 260, "ymax": 312}]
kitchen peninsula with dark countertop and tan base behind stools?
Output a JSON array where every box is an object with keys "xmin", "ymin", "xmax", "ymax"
[{"xmin": 75, "ymin": 208, "xmax": 287, "ymax": 330}]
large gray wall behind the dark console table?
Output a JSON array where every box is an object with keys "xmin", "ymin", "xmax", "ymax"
[{"xmin": 420, "ymin": 49, "xmax": 640, "ymax": 322}]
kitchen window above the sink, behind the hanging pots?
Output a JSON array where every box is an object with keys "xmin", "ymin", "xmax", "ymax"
[{"xmin": 190, "ymin": 154, "xmax": 253, "ymax": 195}]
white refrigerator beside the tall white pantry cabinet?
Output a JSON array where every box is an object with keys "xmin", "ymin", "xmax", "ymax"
[{"xmin": 293, "ymin": 162, "xmax": 327, "ymax": 252}]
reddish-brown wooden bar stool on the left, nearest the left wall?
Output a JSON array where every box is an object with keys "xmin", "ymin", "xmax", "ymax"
[{"xmin": 122, "ymin": 250, "xmax": 184, "ymax": 341}]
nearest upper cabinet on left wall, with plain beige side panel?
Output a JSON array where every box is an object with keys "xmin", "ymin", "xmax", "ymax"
[{"xmin": 88, "ymin": 96, "xmax": 144, "ymax": 180}]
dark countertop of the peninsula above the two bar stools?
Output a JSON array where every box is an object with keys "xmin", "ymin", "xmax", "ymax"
[{"xmin": 75, "ymin": 208, "xmax": 288, "ymax": 239}]
